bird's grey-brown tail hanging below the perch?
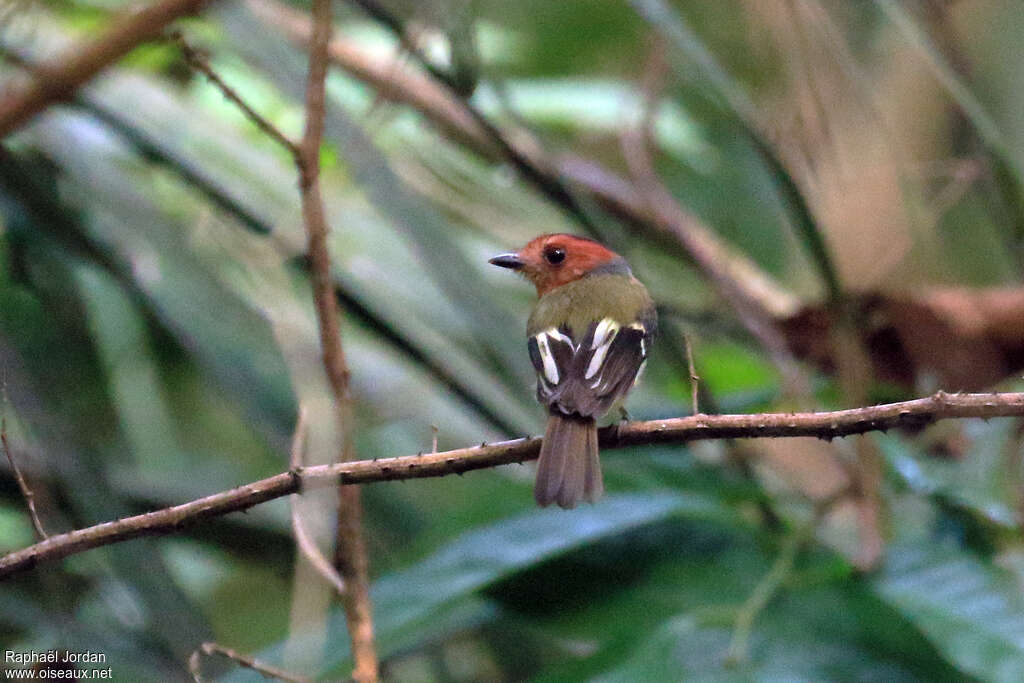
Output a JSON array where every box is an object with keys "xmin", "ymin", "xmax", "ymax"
[{"xmin": 534, "ymin": 414, "xmax": 604, "ymax": 509}]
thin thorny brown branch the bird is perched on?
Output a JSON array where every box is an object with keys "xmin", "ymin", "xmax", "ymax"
[{"xmin": 0, "ymin": 391, "xmax": 1024, "ymax": 580}]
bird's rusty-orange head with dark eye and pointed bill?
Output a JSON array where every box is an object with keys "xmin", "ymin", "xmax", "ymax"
[{"xmin": 488, "ymin": 233, "xmax": 630, "ymax": 296}]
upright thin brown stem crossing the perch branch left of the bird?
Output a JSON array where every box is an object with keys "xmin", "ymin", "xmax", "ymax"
[{"xmin": 298, "ymin": 0, "xmax": 379, "ymax": 683}]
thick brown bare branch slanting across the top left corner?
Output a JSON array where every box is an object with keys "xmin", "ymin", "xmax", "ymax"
[{"xmin": 0, "ymin": 0, "xmax": 210, "ymax": 138}]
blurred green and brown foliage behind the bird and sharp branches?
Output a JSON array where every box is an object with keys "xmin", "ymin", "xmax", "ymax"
[{"xmin": 0, "ymin": 0, "xmax": 1024, "ymax": 681}]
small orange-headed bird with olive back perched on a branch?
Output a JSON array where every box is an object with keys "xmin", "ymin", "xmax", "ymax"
[{"xmin": 489, "ymin": 234, "xmax": 657, "ymax": 508}]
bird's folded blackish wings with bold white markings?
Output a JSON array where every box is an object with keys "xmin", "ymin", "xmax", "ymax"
[{"xmin": 528, "ymin": 317, "xmax": 653, "ymax": 418}]
